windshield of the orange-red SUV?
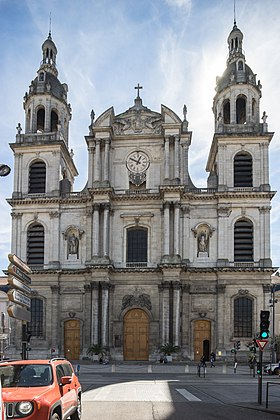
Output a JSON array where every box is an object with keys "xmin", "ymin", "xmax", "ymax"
[{"xmin": 0, "ymin": 364, "xmax": 52, "ymax": 388}]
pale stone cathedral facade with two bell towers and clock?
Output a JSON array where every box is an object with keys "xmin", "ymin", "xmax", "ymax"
[{"xmin": 8, "ymin": 23, "xmax": 274, "ymax": 360}]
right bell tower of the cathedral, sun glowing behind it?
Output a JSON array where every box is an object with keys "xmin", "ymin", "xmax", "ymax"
[{"xmin": 206, "ymin": 21, "xmax": 273, "ymax": 191}]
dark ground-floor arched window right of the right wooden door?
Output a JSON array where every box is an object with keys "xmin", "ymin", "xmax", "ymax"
[{"xmin": 234, "ymin": 297, "xmax": 253, "ymax": 338}]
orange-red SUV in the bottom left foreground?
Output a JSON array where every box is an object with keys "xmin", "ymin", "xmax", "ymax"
[{"xmin": 0, "ymin": 358, "xmax": 81, "ymax": 420}]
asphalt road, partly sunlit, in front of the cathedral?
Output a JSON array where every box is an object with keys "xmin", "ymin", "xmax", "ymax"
[{"xmin": 75, "ymin": 365, "xmax": 280, "ymax": 420}]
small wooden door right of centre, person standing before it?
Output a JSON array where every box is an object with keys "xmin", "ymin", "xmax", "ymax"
[{"xmin": 193, "ymin": 320, "xmax": 211, "ymax": 361}]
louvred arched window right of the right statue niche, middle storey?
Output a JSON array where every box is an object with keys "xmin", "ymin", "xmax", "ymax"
[{"xmin": 234, "ymin": 219, "xmax": 254, "ymax": 262}]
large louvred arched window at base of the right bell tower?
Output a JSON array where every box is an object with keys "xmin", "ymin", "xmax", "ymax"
[{"xmin": 234, "ymin": 152, "xmax": 253, "ymax": 187}]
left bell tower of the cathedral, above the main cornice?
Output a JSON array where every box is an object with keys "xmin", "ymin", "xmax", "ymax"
[{"xmin": 10, "ymin": 32, "xmax": 78, "ymax": 198}]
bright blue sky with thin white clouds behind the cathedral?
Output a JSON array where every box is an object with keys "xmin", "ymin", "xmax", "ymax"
[{"xmin": 0, "ymin": 0, "xmax": 280, "ymax": 269}]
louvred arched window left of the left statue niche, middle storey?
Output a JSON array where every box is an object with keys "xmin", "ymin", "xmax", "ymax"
[{"xmin": 26, "ymin": 223, "xmax": 45, "ymax": 265}]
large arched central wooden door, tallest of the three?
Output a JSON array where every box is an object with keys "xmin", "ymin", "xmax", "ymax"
[{"xmin": 124, "ymin": 309, "xmax": 149, "ymax": 360}]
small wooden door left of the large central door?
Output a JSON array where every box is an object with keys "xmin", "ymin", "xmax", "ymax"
[{"xmin": 64, "ymin": 319, "xmax": 80, "ymax": 360}]
